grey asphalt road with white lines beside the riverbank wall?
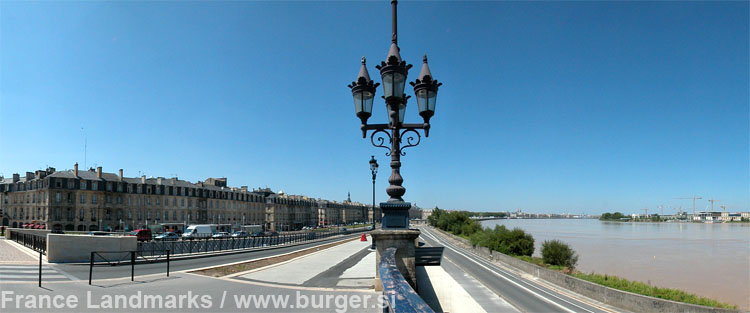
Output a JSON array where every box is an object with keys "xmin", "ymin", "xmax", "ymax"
[{"xmin": 419, "ymin": 227, "xmax": 614, "ymax": 313}]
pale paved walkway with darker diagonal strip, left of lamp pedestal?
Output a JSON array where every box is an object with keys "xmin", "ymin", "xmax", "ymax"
[{"xmin": 236, "ymin": 241, "xmax": 375, "ymax": 288}]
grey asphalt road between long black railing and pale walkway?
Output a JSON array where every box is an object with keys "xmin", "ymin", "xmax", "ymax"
[{"xmin": 50, "ymin": 233, "xmax": 362, "ymax": 280}]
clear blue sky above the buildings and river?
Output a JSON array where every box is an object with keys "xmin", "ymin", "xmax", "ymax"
[{"xmin": 0, "ymin": 1, "xmax": 750, "ymax": 213}]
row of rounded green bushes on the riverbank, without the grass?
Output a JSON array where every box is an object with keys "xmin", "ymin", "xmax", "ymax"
[{"xmin": 427, "ymin": 208, "xmax": 578, "ymax": 270}]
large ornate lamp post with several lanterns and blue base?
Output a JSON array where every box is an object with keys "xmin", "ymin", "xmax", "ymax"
[{"xmin": 349, "ymin": 0, "xmax": 442, "ymax": 229}]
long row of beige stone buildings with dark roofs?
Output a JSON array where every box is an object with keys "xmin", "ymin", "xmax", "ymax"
[{"xmin": 0, "ymin": 163, "xmax": 380, "ymax": 231}]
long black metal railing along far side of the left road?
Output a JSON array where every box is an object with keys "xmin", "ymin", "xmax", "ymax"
[{"xmin": 138, "ymin": 229, "xmax": 364, "ymax": 256}]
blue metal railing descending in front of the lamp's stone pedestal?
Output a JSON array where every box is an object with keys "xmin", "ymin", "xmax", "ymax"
[{"xmin": 378, "ymin": 248, "xmax": 434, "ymax": 313}]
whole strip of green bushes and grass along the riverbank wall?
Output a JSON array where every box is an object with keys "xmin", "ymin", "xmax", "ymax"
[{"xmin": 427, "ymin": 208, "xmax": 737, "ymax": 309}]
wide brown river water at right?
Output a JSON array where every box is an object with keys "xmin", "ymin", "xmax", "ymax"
[{"xmin": 482, "ymin": 219, "xmax": 750, "ymax": 310}]
